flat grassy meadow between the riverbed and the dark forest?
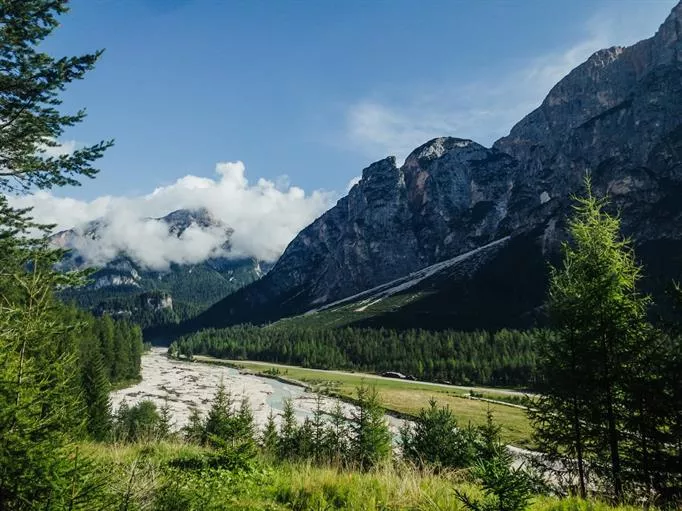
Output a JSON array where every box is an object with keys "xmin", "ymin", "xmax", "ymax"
[{"xmin": 194, "ymin": 356, "xmax": 533, "ymax": 448}]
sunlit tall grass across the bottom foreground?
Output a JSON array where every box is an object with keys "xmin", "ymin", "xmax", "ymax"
[{"xmin": 85, "ymin": 442, "xmax": 639, "ymax": 511}]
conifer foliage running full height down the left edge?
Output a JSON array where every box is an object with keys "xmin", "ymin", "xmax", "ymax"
[{"xmin": 0, "ymin": 0, "xmax": 117, "ymax": 509}]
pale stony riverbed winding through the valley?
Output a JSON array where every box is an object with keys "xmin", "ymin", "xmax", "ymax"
[{"xmin": 111, "ymin": 348, "xmax": 402, "ymax": 435}]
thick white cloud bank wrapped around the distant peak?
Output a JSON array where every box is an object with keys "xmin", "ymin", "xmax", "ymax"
[{"xmin": 10, "ymin": 162, "xmax": 335, "ymax": 269}]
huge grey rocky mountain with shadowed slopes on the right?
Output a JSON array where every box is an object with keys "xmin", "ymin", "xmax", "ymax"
[{"xmin": 184, "ymin": 4, "xmax": 682, "ymax": 336}]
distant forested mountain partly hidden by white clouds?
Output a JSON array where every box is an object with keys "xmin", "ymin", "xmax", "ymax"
[{"xmin": 50, "ymin": 209, "xmax": 268, "ymax": 326}]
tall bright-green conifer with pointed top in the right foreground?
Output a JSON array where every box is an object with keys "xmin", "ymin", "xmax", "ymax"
[{"xmin": 530, "ymin": 179, "xmax": 649, "ymax": 501}]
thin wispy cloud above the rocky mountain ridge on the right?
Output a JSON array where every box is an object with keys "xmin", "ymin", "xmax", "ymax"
[{"xmin": 346, "ymin": 0, "xmax": 676, "ymax": 162}]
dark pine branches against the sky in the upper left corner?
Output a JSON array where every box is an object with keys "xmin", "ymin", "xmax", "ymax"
[{"xmin": 0, "ymin": 0, "xmax": 111, "ymax": 191}]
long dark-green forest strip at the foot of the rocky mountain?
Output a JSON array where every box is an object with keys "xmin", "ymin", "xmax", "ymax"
[{"xmin": 170, "ymin": 326, "xmax": 540, "ymax": 386}]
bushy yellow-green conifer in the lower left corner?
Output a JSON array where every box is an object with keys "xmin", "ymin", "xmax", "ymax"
[{"xmin": 0, "ymin": 261, "xmax": 84, "ymax": 509}]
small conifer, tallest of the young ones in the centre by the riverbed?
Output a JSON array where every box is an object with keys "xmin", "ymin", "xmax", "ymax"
[{"xmin": 350, "ymin": 385, "xmax": 391, "ymax": 470}]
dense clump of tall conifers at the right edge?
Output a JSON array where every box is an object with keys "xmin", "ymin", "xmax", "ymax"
[{"xmin": 529, "ymin": 179, "xmax": 682, "ymax": 501}]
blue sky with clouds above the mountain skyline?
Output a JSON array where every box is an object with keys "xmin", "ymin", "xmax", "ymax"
[{"xmin": 6, "ymin": 0, "xmax": 676, "ymax": 270}]
